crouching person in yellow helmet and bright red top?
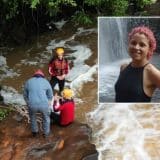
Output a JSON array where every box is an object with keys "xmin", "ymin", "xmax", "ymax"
[{"xmin": 51, "ymin": 88, "xmax": 75, "ymax": 126}]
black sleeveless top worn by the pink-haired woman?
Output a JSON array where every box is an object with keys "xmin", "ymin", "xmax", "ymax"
[{"xmin": 115, "ymin": 63, "xmax": 151, "ymax": 102}]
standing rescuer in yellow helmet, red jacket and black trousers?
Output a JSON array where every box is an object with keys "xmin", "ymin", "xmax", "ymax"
[{"xmin": 49, "ymin": 47, "xmax": 69, "ymax": 93}]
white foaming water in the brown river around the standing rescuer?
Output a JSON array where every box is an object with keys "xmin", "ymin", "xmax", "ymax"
[{"xmin": 0, "ymin": 28, "xmax": 97, "ymax": 106}]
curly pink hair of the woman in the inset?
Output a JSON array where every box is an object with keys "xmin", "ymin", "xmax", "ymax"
[{"xmin": 128, "ymin": 26, "xmax": 156, "ymax": 59}]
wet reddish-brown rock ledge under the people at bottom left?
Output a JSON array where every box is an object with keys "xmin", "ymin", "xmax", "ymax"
[{"xmin": 0, "ymin": 114, "xmax": 98, "ymax": 160}]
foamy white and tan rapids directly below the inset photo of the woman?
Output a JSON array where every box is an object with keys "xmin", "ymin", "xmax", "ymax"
[{"xmin": 88, "ymin": 103, "xmax": 160, "ymax": 160}]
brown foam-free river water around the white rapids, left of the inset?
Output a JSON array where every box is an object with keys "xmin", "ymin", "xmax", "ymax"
[{"xmin": 0, "ymin": 24, "xmax": 97, "ymax": 122}]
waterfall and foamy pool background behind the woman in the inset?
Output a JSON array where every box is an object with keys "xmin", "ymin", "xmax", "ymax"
[{"xmin": 98, "ymin": 18, "xmax": 160, "ymax": 103}]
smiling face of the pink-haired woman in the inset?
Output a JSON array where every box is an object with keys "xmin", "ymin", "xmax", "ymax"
[{"xmin": 128, "ymin": 33, "xmax": 150, "ymax": 61}]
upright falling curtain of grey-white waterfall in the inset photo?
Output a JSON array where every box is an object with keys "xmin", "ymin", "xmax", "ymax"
[{"xmin": 99, "ymin": 17, "xmax": 128, "ymax": 65}]
